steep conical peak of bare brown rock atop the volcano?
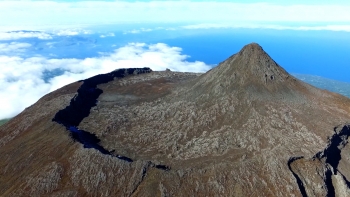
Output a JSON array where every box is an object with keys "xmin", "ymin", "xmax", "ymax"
[{"xmin": 187, "ymin": 43, "xmax": 302, "ymax": 99}]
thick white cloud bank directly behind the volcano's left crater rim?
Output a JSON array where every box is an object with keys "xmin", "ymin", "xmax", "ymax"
[{"xmin": 0, "ymin": 43, "xmax": 211, "ymax": 119}]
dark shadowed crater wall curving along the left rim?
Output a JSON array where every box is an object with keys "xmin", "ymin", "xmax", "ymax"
[{"xmin": 52, "ymin": 68, "xmax": 152, "ymax": 162}]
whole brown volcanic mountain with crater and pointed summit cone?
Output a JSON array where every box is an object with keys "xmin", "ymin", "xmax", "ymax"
[{"xmin": 0, "ymin": 43, "xmax": 350, "ymax": 196}]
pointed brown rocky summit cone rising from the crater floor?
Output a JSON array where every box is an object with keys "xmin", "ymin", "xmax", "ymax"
[{"xmin": 188, "ymin": 43, "xmax": 318, "ymax": 102}]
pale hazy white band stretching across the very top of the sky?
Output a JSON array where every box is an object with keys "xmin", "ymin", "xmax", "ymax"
[{"xmin": 0, "ymin": 1, "xmax": 350, "ymax": 29}]
